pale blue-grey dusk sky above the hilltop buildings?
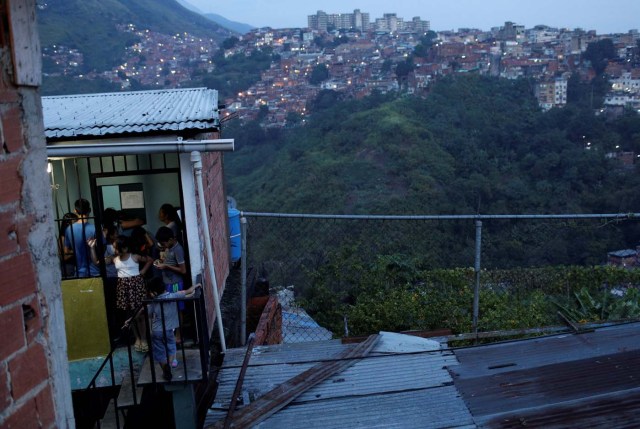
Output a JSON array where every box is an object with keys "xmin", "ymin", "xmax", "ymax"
[{"xmin": 185, "ymin": 0, "xmax": 640, "ymax": 34}]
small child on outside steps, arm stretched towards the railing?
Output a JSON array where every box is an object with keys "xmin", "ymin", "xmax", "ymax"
[{"xmin": 148, "ymin": 277, "xmax": 201, "ymax": 381}]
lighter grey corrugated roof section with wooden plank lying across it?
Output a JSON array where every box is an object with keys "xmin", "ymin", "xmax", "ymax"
[{"xmin": 207, "ymin": 333, "xmax": 475, "ymax": 428}]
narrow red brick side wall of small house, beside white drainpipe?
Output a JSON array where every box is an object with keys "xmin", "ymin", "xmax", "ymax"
[{"xmin": 202, "ymin": 144, "xmax": 230, "ymax": 330}]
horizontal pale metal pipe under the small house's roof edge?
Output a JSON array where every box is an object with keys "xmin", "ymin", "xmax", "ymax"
[{"xmin": 47, "ymin": 137, "xmax": 234, "ymax": 158}]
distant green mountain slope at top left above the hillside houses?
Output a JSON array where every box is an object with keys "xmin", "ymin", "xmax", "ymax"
[{"xmin": 38, "ymin": 0, "xmax": 230, "ymax": 72}]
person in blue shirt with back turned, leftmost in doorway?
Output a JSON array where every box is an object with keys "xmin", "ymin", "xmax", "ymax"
[{"xmin": 64, "ymin": 198, "xmax": 100, "ymax": 277}]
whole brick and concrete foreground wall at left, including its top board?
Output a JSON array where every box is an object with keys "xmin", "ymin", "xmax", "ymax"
[{"xmin": 0, "ymin": 0, "xmax": 74, "ymax": 428}]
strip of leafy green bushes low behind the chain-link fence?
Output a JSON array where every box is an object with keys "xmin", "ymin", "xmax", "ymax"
[{"xmin": 301, "ymin": 251, "xmax": 640, "ymax": 336}]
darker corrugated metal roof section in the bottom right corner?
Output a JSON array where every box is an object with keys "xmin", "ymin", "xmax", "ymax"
[{"xmin": 451, "ymin": 323, "xmax": 640, "ymax": 428}]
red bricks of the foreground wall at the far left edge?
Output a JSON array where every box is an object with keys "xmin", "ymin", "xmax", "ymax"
[{"xmin": 0, "ymin": 47, "xmax": 56, "ymax": 428}]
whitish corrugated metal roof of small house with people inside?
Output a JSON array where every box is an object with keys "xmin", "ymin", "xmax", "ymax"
[{"xmin": 42, "ymin": 88, "xmax": 218, "ymax": 138}]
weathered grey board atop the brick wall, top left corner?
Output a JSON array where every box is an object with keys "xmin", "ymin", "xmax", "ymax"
[{"xmin": 9, "ymin": 0, "xmax": 42, "ymax": 86}]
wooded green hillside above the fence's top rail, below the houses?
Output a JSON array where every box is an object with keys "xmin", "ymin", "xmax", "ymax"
[{"xmin": 224, "ymin": 76, "xmax": 640, "ymax": 214}]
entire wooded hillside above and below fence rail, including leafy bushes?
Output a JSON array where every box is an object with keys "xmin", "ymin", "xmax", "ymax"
[{"xmin": 224, "ymin": 75, "xmax": 640, "ymax": 335}]
